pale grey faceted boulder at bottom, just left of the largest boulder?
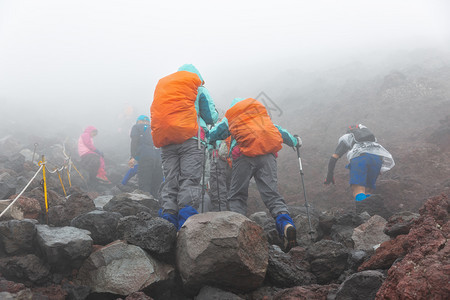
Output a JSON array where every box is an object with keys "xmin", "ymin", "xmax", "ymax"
[{"xmin": 76, "ymin": 241, "xmax": 175, "ymax": 295}]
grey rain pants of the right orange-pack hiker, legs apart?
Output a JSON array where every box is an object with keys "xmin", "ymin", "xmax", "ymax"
[{"xmin": 228, "ymin": 154, "xmax": 289, "ymax": 218}]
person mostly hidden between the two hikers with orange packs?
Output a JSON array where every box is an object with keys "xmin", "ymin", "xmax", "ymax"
[{"xmin": 209, "ymin": 141, "xmax": 231, "ymax": 211}]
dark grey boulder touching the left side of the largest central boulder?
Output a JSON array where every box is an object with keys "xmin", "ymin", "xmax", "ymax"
[{"xmin": 117, "ymin": 212, "xmax": 177, "ymax": 254}]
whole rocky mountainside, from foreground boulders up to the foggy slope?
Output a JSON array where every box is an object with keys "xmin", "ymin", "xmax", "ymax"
[{"xmin": 0, "ymin": 54, "xmax": 450, "ymax": 300}]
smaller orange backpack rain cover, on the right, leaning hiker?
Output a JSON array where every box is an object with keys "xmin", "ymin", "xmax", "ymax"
[{"xmin": 225, "ymin": 98, "xmax": 283, "ymax": 157}]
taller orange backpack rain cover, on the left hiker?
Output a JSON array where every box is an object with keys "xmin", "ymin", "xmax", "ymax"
[{"xmin": 150, "ymin": 71, "xmax": 202, "ymax": 148}]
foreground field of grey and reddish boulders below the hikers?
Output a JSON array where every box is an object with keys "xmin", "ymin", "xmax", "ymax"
[{"xmin": 0, "ymin": 137, "xmax": 450, "ymax": 299}]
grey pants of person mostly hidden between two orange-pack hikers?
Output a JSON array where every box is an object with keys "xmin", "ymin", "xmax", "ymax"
[{"xmin": 209, "ymin": 157, "xmax": 229, "ymax": 211}]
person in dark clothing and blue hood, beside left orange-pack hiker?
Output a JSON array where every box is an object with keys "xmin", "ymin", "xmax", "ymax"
[{"xmin": 127, "ymin": 115, "xmax": 163, "ymax": 198}]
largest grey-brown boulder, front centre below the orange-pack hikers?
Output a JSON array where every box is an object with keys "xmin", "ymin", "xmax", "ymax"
[{"xmin": 176, "ymin": 212, "xmax": 269, "ymax": 294}]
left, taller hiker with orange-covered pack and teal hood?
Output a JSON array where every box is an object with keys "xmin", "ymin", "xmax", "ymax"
[{"xmin": 150, "ymin": 64, "xmax": 218, "ymax": 229}]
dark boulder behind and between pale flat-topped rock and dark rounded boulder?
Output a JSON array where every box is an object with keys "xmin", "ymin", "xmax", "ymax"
[{"xmin": 70, "ymin": 210, "xmax": 122, "ymax": 245}]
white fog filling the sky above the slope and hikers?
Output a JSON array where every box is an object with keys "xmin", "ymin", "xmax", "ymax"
[{"xmin": 0, "ymin": 0, "xmax": 450, "ymax": 136}]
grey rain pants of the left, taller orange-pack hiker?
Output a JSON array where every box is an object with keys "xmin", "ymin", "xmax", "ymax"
[{"xmin": 161, "ymin": 139, "xmax": 204, "ymax": 213}]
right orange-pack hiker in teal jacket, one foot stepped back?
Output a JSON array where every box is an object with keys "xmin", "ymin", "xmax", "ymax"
[{"xmin": 208, "ymin": 98, "xmax": 298, "ymax": 252}]
